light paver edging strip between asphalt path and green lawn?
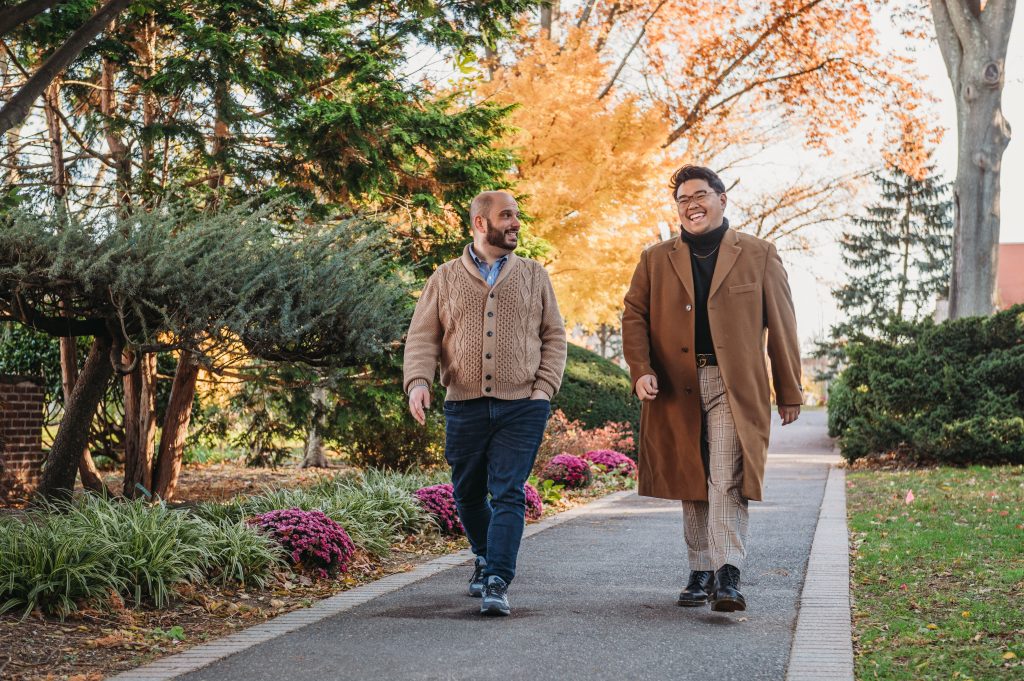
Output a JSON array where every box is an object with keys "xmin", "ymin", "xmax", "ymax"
[{"xmin": 785, "ymin": 466, "xmax": 854, "ymax": 681}]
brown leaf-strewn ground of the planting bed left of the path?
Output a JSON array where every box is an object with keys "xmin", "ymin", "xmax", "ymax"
[{"xmin": 0, "ymin": 463, "xmax": 635, "ymax": 681}]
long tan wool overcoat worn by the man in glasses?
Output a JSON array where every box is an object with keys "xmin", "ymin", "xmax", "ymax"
[{"xmin": 623, "ymin": 228, "xmax": 803, "ymax": 501}]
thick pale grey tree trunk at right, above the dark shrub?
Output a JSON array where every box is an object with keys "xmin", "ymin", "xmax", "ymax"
[{"xmin": 931, "ymin": 0, "xmax": 1016, "ymax": 318}]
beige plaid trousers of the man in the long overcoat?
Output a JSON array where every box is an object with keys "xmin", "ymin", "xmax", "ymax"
[{"xmin": 683, "ymin": 367, "xmax": 750, "ymax": 570}]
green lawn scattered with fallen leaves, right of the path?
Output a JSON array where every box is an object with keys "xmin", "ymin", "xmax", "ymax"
[{"xmin": 847, "ymin": 466, "xmax": 1024, "ymax": 681}]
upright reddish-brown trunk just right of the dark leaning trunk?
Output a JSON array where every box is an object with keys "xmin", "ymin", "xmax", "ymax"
[{"xmin": 123, "ymin": 352, "xmax": 157, "ymax": 499}]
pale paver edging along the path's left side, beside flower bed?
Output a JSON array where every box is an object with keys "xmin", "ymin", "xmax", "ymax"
[{"xmin": 108, "ymin": 491, "xmax": 635, "ymax": 681}]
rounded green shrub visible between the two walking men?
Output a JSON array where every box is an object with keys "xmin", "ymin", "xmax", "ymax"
[{"xmin": 551, "ymin": 343, "xmax": 640, "ymax": 441}]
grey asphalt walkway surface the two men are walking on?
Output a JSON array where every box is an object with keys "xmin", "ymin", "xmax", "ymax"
[{"xmin": 181, "ymin": 405, "xmax": 835, "ymax": 681}]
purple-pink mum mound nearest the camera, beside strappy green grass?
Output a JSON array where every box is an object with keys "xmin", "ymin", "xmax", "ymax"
[{"xmin": 249, "ymin": 508, "xmax": 355, "ymax": 578}]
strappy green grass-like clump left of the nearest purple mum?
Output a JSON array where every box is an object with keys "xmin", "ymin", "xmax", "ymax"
[{"xmin": 0, "ymin": 495, "xmax": 281, "ymax": 616}]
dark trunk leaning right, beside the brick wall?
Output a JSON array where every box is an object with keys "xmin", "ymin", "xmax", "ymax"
[{"xmin": 39, "ymin": 336, "xmax": 114, "ymax": 499}]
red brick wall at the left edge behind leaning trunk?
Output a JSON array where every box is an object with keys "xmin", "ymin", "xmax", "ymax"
[{"xmin": 0, "ymin": 374, "xmax": 43, "ymax": 500}]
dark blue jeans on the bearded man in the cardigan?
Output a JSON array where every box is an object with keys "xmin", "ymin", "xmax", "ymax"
[{"xmin": 444, "ymin": 397, "xmax": 551, "ymax": 583}]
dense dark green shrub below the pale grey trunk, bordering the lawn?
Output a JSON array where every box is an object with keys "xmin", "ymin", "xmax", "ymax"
[{"xmin": 828, "ymin": 305, "xmax": 1024, "ymax": 464}]
